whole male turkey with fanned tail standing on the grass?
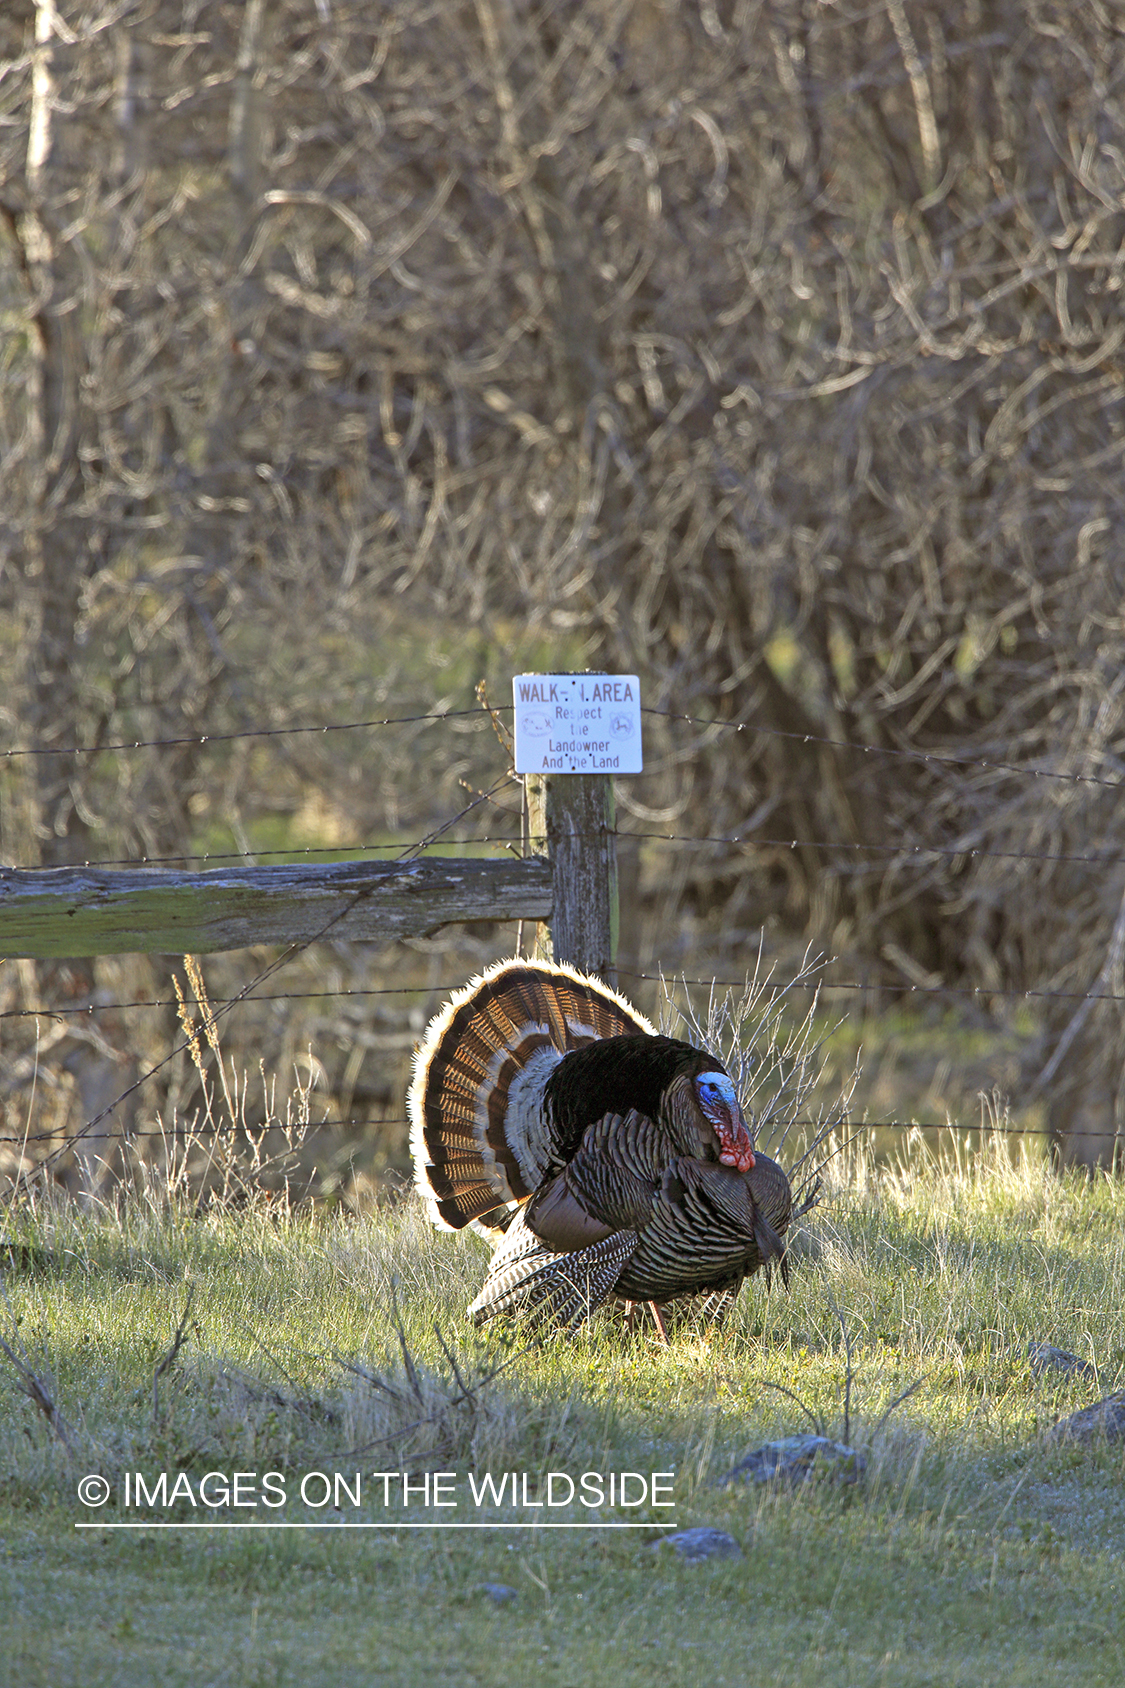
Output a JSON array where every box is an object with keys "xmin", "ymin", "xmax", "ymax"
[{"xmin": 409, "ymin": 960, "xmax": 792, "ymax": 1334}]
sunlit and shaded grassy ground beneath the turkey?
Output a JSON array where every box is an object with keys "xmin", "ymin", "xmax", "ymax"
[{"xmin": 0, "ymin": 1156, "xmax": 1125, "ymax": 1688}]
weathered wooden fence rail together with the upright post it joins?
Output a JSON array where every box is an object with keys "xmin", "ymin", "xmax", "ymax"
[{"xmin": 0, "ymin": 775, "xmax": 617, "ymax": 974}]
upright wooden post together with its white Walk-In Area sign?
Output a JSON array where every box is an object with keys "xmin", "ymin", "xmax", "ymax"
[{"xmin": 512, "ymin": 674, "xmax": 642, "ymax": 984}]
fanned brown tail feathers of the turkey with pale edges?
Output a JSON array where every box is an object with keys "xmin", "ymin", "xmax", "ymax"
[{"xmin": 407, "ymin": 960, "xmax": 654, "ymax": 1231}]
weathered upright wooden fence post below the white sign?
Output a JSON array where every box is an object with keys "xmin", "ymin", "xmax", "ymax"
[{"xmin": 524, "ymin": 773, "xmax": 618, "ymax": 984}]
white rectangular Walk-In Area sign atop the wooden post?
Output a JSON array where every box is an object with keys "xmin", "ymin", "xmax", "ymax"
[{"xmin": 512, "ymin": 674, "xmax": 644, "ymax": 773}]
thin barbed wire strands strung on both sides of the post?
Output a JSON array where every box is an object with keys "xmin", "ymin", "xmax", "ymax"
[{"xmin": 0, "ymin": 706, "xmax": 1125, "ymax": 1195}]
